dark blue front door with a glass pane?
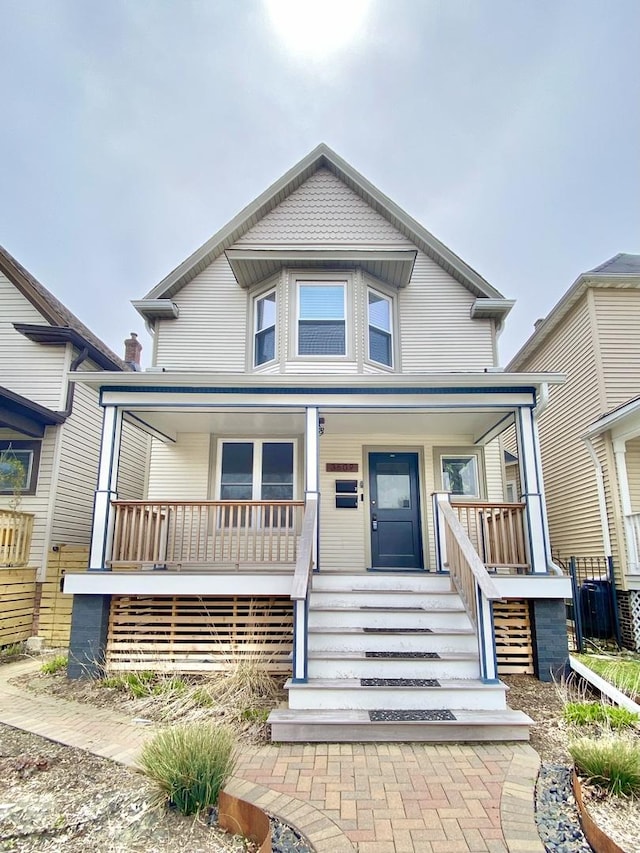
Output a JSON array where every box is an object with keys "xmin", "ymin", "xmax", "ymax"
[{"xmin": 369, "ymin": 453, "xmax": 422, "ymax": 569}]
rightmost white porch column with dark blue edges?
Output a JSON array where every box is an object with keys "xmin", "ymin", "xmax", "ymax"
[{"xmin": 516, "ymin": 407, "xmax": 551, "ymax": 573}]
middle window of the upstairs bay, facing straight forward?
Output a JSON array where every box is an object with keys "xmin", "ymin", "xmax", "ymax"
[{"xmin": 297, "ymin": 281, "xmax": 347, "ymax": 356}]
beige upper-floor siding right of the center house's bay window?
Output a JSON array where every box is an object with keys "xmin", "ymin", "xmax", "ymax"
[{"xmin": 399, "ymin": 253, "xmax": 494, "ymax": 373}]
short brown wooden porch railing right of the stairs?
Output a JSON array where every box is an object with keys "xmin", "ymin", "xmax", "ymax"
[{"xmin": 451, "ymin": 501, "xmax": 531, "ymax": 574}]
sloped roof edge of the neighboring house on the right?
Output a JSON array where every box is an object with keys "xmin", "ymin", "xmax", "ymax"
[{"xmin": 505, "ymin": 252, "xmax": 640, "ymax": 371}]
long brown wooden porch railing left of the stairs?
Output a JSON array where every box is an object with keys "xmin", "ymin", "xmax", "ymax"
[{"xmin": 109, "ymin": 500, "xmax": 304, "ymax": 569}]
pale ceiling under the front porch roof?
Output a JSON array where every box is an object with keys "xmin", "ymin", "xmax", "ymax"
[{"xmin": 129, "ymin": 408, "xmax": 513, "ymax": 442}]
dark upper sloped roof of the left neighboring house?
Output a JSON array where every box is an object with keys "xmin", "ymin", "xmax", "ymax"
[{"xmin": 0, "ymin": 246, "xmax": 129, "ymax": 370}]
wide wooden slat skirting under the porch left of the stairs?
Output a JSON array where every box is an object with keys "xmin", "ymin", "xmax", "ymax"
[{"xmin": 106, "ymin": 596, "xmax": 293, "ymax": 673}]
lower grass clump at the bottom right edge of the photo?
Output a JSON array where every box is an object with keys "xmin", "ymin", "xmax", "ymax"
[{"xmin": 569, "ymin": 737, "xmax": 640, "ymax": 796}]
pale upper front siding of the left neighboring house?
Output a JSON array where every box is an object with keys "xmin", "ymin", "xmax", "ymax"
[{"xmin": 0, "ymin": 273, "xmax": 65, "ymax": 410}]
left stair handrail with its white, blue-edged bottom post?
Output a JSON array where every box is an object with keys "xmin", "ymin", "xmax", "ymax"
[{"xmin": 291, "ymin": 494, "xmax": 318, "ymax": 682}]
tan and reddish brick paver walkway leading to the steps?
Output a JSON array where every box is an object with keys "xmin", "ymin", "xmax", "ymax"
[{"xmin": 0, "ymin": 662, "xmax": 544, "ymax": 853}]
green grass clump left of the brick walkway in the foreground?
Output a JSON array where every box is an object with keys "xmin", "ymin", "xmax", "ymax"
[{"xmin": 140, "ymin": 722, "xmax": 235, "ymax": 815}]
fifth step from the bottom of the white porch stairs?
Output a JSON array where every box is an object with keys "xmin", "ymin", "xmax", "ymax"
[{"xmin": 309, "ymin": 605, "xmax": 471, "ymax": 630}]
